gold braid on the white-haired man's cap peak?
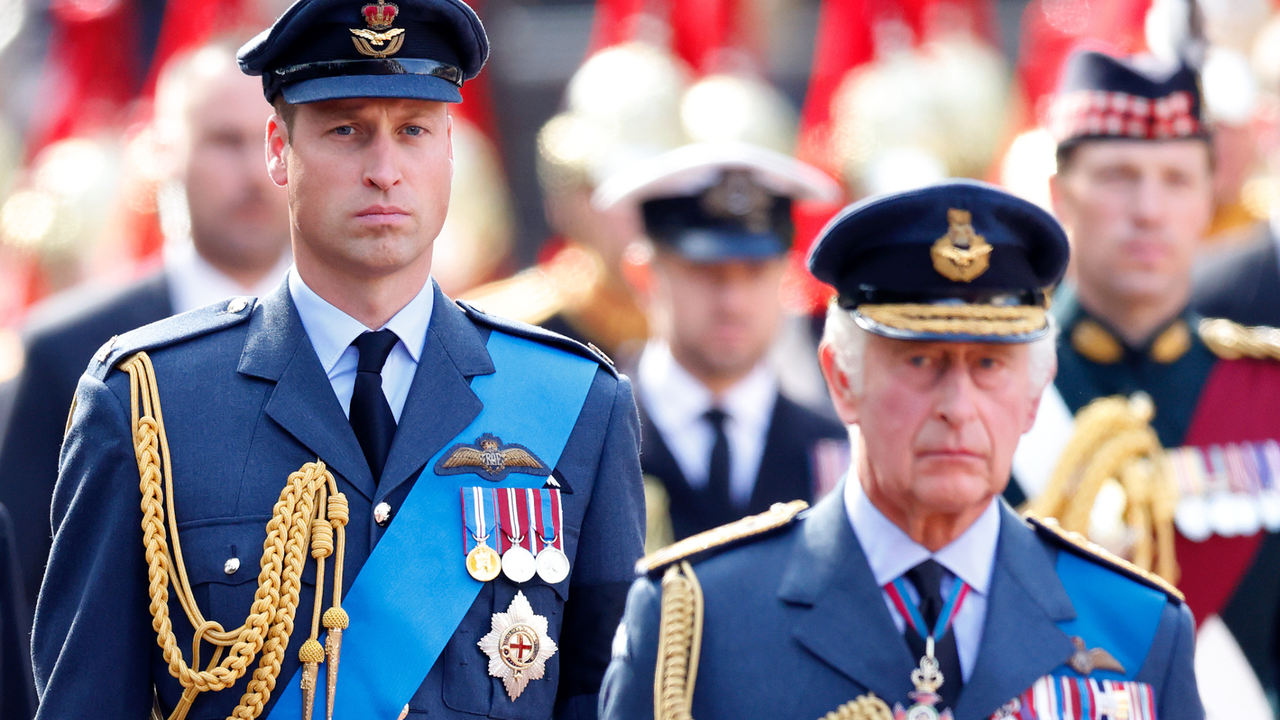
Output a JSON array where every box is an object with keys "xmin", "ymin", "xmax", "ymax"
[{"xmin": 858, "ymin": 302, "xmax": 1047, "ymax": 336}]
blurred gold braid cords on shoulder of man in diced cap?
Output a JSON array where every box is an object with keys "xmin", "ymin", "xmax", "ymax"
[{"xmin": 1027, "ymin": 393, "xmax": 1179, "ymax": 583}]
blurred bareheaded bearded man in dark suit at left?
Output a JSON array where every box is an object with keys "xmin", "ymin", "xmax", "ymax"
[{"xmin": 0, "ymin": 41, "xmax": 291, "ymax": 621}]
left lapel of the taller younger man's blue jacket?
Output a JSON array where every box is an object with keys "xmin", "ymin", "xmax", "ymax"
[{"xmin": 238, "ymin": 282, "xmax": 374, "ymax": 498}]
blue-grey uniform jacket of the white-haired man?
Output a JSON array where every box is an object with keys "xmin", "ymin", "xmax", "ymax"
[{"xmin": 600, "ymin": 489, "xmax": 1204, "ymax": 720}]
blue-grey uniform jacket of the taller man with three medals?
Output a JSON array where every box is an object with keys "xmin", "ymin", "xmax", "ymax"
[{"xmin": 33, "ymin": 286, "xmax": 644, "ymax": 719}]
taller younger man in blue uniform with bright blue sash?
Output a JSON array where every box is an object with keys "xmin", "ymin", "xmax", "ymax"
[{"xmin": 33, "ymin": 0, "xmax": 643, "ymax": 719}]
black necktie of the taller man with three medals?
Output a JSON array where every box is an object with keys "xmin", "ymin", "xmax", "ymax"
[{"xmin": 351, "ymin": 331, "xmax": 399, "ymax": 483}]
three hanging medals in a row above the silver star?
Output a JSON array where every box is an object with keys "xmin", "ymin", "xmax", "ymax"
[{"xmin": 462, "ymin": 487, "xmax": 570, "ymax": 585}]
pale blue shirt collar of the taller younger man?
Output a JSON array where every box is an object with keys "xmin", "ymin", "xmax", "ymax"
[{"xmin": 289, "ymin": 266, "xmax": 435, "ymax": 375}]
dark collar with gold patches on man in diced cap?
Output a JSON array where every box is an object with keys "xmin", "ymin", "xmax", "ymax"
[{"xmin": 1055, "ymin": 287, "xmax": 1199, "ymax": 365}]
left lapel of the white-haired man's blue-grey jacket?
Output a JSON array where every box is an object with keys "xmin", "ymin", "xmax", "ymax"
[{"xmin": 778, "ymin": 482, "xmax": 915, "ymax": 703}]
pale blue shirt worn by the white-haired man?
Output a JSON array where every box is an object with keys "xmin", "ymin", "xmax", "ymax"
[{"xmin": 845, "ymin": 471, "xmax": 1000, "ymax": 680}]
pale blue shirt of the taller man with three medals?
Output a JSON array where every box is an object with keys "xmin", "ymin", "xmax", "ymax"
[{"xmin": 289, "ymin": 268, "xmax": 435, "ymax": 423}]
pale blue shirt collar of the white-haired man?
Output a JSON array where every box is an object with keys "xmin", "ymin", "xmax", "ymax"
[{"xmin": 844, "ymin": 473, "xmax": 1000, "ymax": 594}]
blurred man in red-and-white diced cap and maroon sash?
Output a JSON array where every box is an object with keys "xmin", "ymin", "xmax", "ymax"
[{"xmin": 1006, "ymin": 50, "xmax": 1280, "ymax": 717}]
